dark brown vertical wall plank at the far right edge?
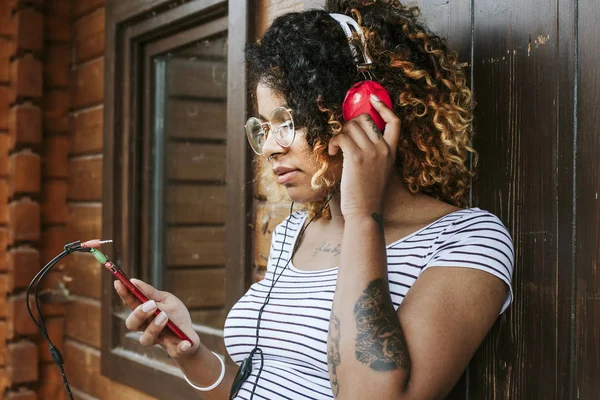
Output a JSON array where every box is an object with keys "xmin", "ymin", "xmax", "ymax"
[{"xmin": 573, "ymin": 0, "xmax": 600, "ymax": 399}]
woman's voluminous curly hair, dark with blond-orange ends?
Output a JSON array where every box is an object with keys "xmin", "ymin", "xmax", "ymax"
[{"xmin": 246, "ymin": 0, "xmax": 477, "ymax": 216}]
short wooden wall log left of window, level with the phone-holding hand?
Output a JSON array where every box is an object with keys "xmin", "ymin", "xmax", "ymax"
[{"xmin": 65, "ymin": 297, "xmax": 100, "ymax": 348}]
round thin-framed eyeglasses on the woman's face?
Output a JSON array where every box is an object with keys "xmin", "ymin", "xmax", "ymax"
[{"xmin": 241, "ymin": 107, "xmax": 296, "ymax": 155}]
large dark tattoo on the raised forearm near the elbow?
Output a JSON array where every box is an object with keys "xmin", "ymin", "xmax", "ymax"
[{"xmin": 354, "ymin": 278, "xmax": 410, "ymax": 371}]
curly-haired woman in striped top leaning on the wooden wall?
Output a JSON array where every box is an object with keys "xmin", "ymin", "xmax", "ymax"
[{"xmin": 115, "ymin": 0, "xmax": 514, "ymax": 399}]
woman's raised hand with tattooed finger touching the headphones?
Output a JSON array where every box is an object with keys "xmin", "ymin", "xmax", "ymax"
[{"xmin": 328, "ymin": 97, "xmax": 400, "ymax": 218}]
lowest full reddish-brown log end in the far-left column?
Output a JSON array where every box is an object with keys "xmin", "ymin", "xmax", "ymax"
[{"xmin": 6, "ymin": 340, "xmax": 38, "ymax": 385}]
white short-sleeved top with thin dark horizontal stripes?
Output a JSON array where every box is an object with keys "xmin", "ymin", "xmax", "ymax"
[{"xmin": 225, "ymin": 208, "xmax": 514, "ymax": 400}]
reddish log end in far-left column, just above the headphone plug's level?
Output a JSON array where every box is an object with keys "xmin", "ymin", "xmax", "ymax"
[{"xmin": 8, "ymin": 198, "xmax": 40, "ymax": 244}]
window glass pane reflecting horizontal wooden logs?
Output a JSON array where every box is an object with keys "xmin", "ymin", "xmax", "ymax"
[{"xmin": 150, "ymin": 35, "xmax": 227, "ymax": 329}]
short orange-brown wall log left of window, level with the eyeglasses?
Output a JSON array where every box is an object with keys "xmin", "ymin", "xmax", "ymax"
[{"xmin": 70, "ymin": 106, "xmax": 104, "ymax": 155}]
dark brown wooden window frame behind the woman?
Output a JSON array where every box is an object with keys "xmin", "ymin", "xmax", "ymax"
[{"xmin": 101, "ymin": 0, "xmax": 252, "ymax": 399}]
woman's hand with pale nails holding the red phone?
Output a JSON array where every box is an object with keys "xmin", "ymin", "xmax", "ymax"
[{"xmin": 115, "ymin": 279, "xmax": 200, "ymax": 359}]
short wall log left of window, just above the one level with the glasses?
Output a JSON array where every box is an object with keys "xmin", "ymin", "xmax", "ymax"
[{"xmin": 71, "ymin": 58, "xmax": 104, "ymax": 109}]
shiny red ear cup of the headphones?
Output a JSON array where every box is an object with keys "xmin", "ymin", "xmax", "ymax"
[{"xmin": 342, "ymin": 81, "xmax": 393, "ymax": 131}]
